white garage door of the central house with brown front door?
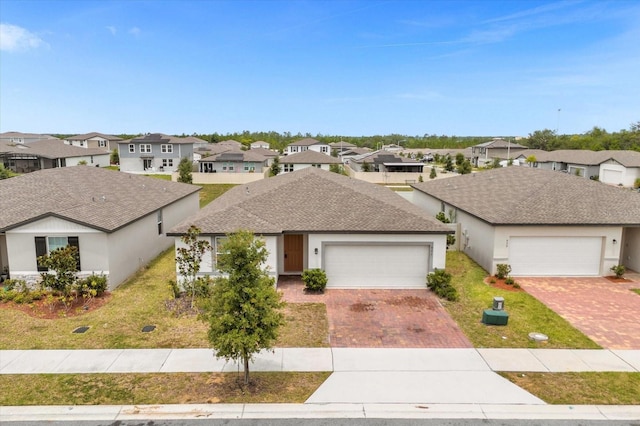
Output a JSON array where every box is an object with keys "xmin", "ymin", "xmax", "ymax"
[{"xmin": 324, "ymin": 243, "xmax": 430, "ymax": 288}]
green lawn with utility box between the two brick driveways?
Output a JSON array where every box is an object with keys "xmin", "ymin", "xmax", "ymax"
[{"xmin": 442, "ymin": 251, "xmax": 600, "ymax": 349}]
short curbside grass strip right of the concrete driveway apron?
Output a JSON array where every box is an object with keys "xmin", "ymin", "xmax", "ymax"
[{"xmin": 500, "ymin": 372, "xmax": 640, "ymax": 405}]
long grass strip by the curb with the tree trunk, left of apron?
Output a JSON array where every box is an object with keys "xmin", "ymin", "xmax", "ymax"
[{"xmin": 0, "ymin": 372, "xmax": 330, "ymax": 406}]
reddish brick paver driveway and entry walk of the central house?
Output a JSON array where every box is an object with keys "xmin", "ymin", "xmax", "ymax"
[{"xmin": 278, "ymin": 277, "xmax": 472, "ymax": 348}]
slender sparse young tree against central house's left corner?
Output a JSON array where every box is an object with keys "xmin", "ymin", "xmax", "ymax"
[{"xmin": 176, "ymin": 225, "xmax": 211, "ymax": 309}]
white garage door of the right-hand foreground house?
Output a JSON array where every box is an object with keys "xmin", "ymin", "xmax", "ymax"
[{"xmin": 509, "ymin": 237, "xmax": 602, "ymax": 277}]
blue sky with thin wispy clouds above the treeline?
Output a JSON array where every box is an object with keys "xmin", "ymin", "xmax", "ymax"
[{"xmin": 0, "ymin": 0, "xmax": 640, "ymax": 136}]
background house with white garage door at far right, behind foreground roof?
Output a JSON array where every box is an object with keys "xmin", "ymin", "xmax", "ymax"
[{"xmin": 516, "ymin": 149, "xmax": 640, "ymax": 187}]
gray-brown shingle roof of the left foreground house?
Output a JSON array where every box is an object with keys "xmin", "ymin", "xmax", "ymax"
[{"xmin": 0, "ymin": 166, "xmax": 200, "ymax": 232}]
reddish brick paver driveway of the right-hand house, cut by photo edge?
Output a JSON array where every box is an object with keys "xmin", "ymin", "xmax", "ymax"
[{"xmin": 518, "ymin": 277, "xmax": 640, "ymax": 349}]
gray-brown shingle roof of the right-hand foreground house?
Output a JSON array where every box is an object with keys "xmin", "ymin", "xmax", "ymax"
[{"xmin": 412, "ymin": 167, "xmax": 640, "ymax": 225}]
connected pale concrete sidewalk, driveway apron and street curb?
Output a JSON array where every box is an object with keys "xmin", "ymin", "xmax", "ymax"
[{"xmin": 0, "ymin": 348, "xmax": 640, "ymax": 421}]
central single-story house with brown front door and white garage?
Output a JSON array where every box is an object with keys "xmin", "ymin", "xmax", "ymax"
[{"xmin": 169, "ymin": 167, "xmax": 452, "ymax": 288}]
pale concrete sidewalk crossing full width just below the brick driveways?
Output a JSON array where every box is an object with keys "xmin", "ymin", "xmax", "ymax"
[{"xmin": 0, "ymin": 348, "xmax": 640, "ymax": 374}]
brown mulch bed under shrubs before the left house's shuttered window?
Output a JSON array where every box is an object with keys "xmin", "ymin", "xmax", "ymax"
[{"xmin": 0, "ymin": 291, "xmax": 111, "ymax": 319}]
